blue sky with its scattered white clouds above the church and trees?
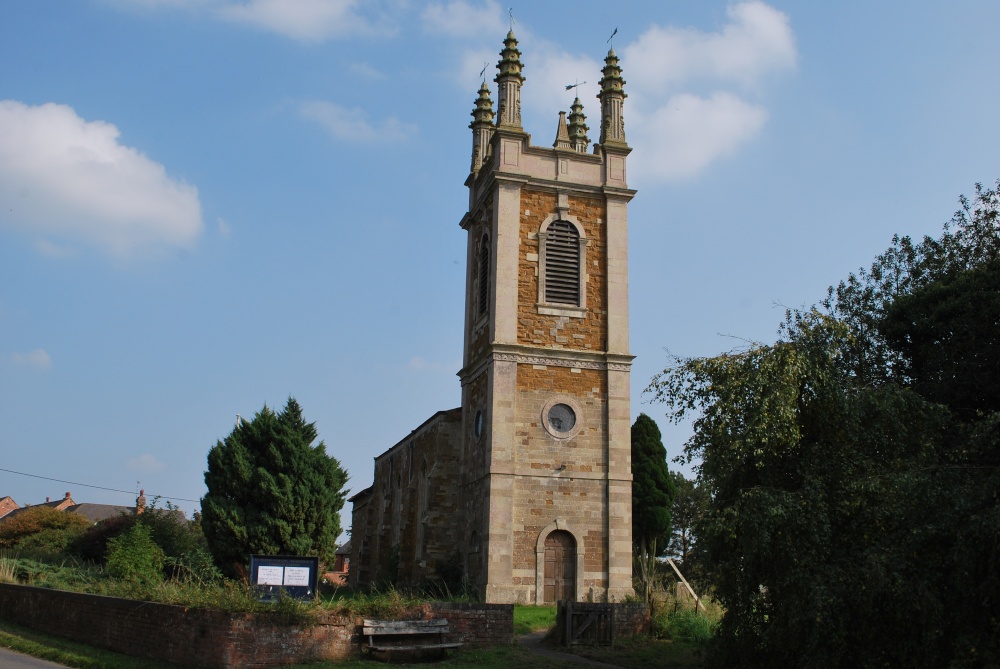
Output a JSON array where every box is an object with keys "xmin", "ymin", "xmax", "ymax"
[{"xmin": 0, "ymin": 0, "xmax": 1000, "ymax": 521}]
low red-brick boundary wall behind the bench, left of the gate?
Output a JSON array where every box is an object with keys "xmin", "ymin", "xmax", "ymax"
[{"xmin": 0, "ymin": 584, "xmax": 514, "ymax": 669}]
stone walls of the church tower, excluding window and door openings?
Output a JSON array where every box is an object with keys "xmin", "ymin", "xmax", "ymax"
[{"xmin": 460, "ymin": 35, "xmax": 634, "ymax": 603}]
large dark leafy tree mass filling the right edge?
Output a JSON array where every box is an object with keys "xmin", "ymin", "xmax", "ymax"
[{"xmin": 650, "ymin": 180, "xmax": 1000, "ymax": 667}]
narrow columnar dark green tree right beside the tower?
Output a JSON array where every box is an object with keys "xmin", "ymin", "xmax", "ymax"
[{"xmin": 632, "ymin": 414, "xmax": 674, "ymax": 597}]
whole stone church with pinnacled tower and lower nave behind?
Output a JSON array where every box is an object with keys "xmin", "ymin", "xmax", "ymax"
[{"xmin": 348, "ymin": 30, "xmax": 635, "ymax": 604}]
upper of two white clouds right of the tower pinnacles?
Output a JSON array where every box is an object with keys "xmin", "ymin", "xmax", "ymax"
[{"xmin": 622, "ymin": 1, "xmax": 797, "ymax": 91}]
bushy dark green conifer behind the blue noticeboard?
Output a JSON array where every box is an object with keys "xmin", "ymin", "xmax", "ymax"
[{"xmin": 201, "ymin": 398, "xmax": 347, "ymax": 575}]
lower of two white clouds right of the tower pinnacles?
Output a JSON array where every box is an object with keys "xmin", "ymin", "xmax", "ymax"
[{"xmin": 630, "ymin": 92, "xmax": 768, "ymax": 181}]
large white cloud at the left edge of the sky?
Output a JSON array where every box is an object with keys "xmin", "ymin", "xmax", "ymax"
[{"xmin": 0, "ymin": 100, "xmax": 202, "ymax": 257}]
